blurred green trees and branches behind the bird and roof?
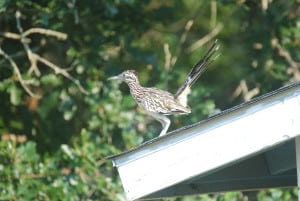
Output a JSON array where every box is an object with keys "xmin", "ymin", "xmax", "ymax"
[{"xmin": 0, "ymin": 0, "xmax": 300, "ymax": 201}]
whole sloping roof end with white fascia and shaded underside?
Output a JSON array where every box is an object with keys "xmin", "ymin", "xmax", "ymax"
[{"xmin": 108, "ymin": 83, "xmax": 300, "ymax": 200}]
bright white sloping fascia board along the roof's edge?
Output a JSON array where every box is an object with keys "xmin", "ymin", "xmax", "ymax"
[{"xmin": 110, "ymin": 83, "xmax": 300, "ymax": 200}]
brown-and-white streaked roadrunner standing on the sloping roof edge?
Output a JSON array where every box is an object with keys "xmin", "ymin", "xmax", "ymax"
[{"xmin": 109, "ymin": 40, "xmax": 219, "ymax": 136}]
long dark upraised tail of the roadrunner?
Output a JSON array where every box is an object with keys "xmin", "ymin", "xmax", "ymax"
[{"xmin": 174, "ymin": 40, "xmax": 219, "ymax": 107}]
